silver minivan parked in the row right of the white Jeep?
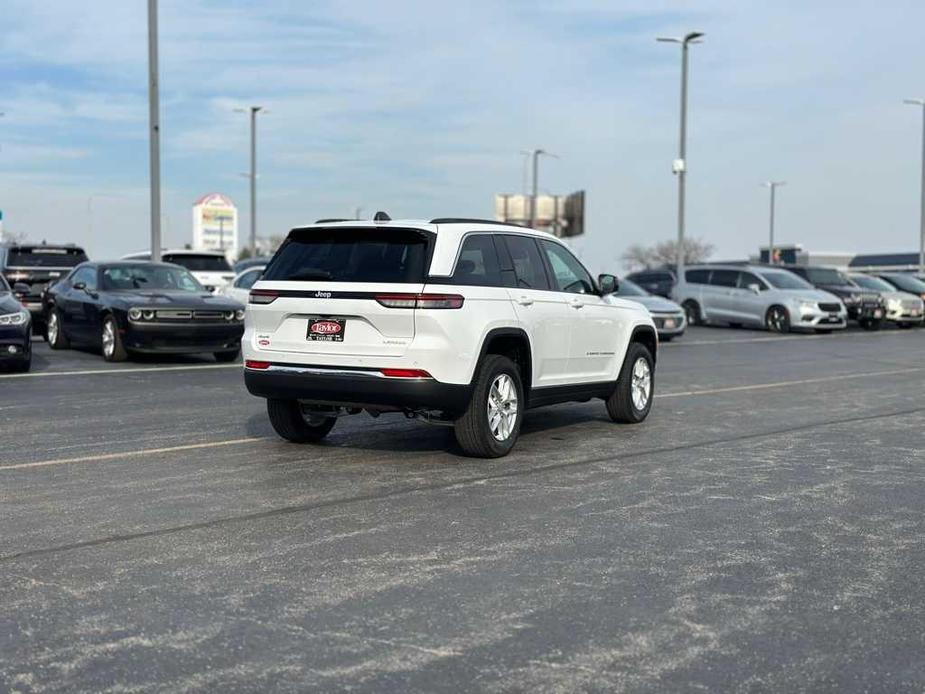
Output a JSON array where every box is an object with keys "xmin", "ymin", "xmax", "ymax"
[{"xmin": 675, "ymin": 265, "xmax": 848, "ymax": 333}]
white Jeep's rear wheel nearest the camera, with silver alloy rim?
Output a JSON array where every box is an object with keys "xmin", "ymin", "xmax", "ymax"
[{"xmin": 453, "ymin": 354, "xmax": 525, "ymax": 458}]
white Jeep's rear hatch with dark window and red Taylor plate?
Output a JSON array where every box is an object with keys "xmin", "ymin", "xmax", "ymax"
[{"xmin": 248, "ymin": 227, "xmax": 433, "ymax": 357}]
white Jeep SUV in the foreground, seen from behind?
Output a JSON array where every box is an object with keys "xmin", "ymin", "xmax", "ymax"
[{"xmin": 242, "ymin": 213, "xmax": 658, "ymax": 457}]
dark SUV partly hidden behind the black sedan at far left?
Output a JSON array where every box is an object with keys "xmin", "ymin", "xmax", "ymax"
[{"xmin": 0, "ymin": 243, "xmax": 87, "ymax": 332}]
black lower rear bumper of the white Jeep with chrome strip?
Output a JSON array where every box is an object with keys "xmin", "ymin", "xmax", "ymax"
[{"xmin": 244, "ymin": 364, "xmax": 471, "ymax": 413}]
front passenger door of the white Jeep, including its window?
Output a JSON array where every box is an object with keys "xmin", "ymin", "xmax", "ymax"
[{"xmin": 540, "ymin": 239, "xmax": 625, "ymax": 383}]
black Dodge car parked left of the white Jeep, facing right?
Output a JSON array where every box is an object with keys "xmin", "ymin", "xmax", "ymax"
[{"xmin": 45, "ymin": 261, "xmax": 244, "ymax": 362}]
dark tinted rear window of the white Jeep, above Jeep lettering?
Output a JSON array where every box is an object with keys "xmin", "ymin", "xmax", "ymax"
[{"xmin": 261, "ymin": 229, "xmax": 428, "ymax": 284}]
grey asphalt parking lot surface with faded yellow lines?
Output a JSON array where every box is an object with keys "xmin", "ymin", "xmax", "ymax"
[{"xmin": 0, "ymin": 328, "xmax": 925, "ymax": 692}]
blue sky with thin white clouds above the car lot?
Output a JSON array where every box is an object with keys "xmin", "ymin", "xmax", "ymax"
[{"xmin": 0, "ymin": 0, "xmax": 925, "ymax": 270}]
